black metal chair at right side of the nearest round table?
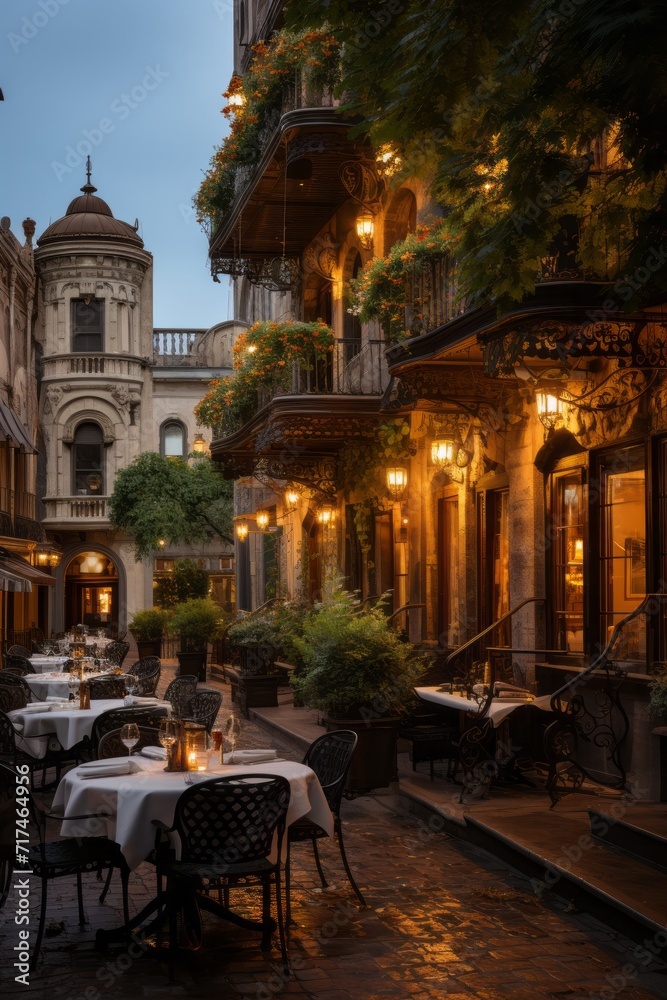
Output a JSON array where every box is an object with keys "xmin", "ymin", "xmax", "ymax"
[{"xmin": 285, "ymin": 729, "xmax": 366, "ymax": 921}]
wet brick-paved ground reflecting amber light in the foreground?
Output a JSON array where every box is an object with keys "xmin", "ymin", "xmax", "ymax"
[{"xmin": 0, "ymin": 676, "xmax": 667, "ymax": 1000}]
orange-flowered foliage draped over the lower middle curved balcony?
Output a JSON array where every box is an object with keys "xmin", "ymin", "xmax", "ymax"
[{"xmin": 195, "ymin": 320, "xmax": 336, "ymax": 431}]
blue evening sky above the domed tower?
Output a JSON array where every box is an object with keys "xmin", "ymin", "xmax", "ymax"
[{"xmin": 0, "ymin": 0, "xmax": 233, "ymax": 327}]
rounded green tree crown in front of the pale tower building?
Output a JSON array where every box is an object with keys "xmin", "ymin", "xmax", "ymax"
[{"xmin": 110, "ymin": 451, "xmax": 233, "ymax": 560}]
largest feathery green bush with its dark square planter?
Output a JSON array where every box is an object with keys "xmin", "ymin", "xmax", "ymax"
[{"xmin": 291, "ymin": 590, "xmax": 424, "ymax": 791}]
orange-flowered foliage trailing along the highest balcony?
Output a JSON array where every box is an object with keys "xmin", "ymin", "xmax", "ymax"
[{"xmin": 194, "ymin": 29, "xmax": 340, "ymax": 232}]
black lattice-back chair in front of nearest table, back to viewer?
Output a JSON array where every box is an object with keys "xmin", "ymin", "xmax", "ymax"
[{"xmin": 158, "ymin": 773, "xmax": 290, "ymax": 969}]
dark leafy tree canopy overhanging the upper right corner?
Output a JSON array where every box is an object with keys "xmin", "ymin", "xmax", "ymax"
[{"xmin": 287, "ymin": 0, "xmax": 667, "ymax": 305}]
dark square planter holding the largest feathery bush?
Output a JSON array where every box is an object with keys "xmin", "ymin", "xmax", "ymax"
[{"xmin": 324, "ymin": 717, "xmax": 399, "ymax": 792}]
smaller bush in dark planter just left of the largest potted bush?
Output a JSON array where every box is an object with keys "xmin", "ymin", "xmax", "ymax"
[{"xmin": 227, "ymin": 615, "xmax": 280, "ymax": 715}]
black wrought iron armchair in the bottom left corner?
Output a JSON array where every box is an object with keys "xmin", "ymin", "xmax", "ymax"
[{"xmin": 0, "ymin": 764, "xmax": 130, "ymax": 969}]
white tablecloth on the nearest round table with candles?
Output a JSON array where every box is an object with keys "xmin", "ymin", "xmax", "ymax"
[{"xmin": 53, "ymin": 754, "xmax": 333, "ymax": 868}]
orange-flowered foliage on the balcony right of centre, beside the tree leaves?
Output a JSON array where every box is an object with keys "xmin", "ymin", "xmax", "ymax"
[{"xmin": 350, "ymin": 219, "xmax": 453, "ymax": 342}]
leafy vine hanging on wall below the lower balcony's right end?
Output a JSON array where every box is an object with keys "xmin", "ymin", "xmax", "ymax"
[{"xmin": 337, "ymin": 417, "xmax": 410, "ymax": 552}]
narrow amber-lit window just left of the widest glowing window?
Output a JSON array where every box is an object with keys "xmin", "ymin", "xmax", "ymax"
[{"xmin": 551, "ymin": 468, "xmax": 584, "ymax": 653}]
